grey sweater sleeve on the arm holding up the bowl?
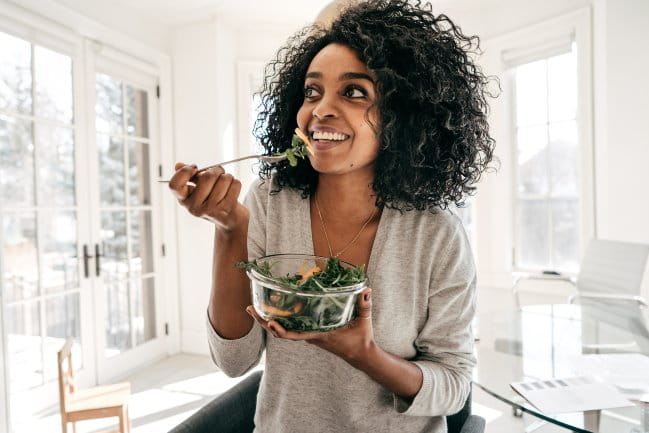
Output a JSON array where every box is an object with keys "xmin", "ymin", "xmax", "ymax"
[{"xmin": 394, "ymin": 226, "xmax": 476, "ymax": 416}]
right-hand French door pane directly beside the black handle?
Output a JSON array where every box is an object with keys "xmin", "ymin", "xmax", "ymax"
[{"xmin": 100, "ymin": 211, "xmax": 128, "ymax": 283}]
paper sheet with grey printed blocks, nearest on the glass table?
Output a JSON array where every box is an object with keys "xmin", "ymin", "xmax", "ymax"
[{"xmin": 511, "ymin": 376, "xmax": 632, "ymax": 414}]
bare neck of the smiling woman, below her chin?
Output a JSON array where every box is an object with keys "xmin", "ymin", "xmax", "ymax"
[{"xmin": 315, "ymin": 170, "xmax": 376, "ymax": 223}]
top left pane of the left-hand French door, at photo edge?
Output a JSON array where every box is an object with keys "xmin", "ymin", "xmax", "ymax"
[{"xmin": 0, "ymin": 32, "xmax": 32, "ymax": 114}]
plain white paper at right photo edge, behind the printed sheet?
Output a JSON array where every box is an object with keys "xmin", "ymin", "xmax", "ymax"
[{"xmin": 572, "ymin": 353, "xmax": 649, "ymax": 398}]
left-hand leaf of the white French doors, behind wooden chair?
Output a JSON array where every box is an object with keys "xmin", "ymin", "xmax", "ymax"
[{"xmin": 0, "ymin": 28, "xmax": 96, "ymax": 430}]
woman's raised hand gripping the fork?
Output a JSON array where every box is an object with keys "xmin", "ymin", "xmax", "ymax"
[{"xmin": 169, "ymin": 162, "xmax": 249, "ymax": 232}]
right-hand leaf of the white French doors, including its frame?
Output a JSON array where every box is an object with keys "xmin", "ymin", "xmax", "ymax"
[{"xmin": 88, "ymin": 49, "xmax": 165, "ymax": 382}]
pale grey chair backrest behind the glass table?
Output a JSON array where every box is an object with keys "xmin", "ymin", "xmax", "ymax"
[{"xmin": 577, "ymin": 239, "xmax": 649, "ymax": 295}]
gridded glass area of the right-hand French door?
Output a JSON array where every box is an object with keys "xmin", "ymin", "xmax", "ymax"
[{"xmin": 95, "ymin": 73, "xmax": 156, "ymax": 357}]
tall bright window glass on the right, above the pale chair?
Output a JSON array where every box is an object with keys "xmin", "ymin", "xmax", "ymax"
[{"xmin": 513, "ymin": 43, "xmax": 580, "ymax": 272}]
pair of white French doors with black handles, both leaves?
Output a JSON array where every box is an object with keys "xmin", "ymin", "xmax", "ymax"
[{"xmin": 0, "ymin": 21, "xmax": 165, "ymax": 431}]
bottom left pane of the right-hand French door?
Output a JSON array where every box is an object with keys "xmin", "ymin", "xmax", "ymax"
[{"xmin": 105, "ymin": 281, "xmax": 132, "ymax": 358}]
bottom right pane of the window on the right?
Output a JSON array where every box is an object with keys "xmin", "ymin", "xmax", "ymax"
[{"xmin": 552, "ymin": 199, "xmax": 579, "ymax": 272}]
